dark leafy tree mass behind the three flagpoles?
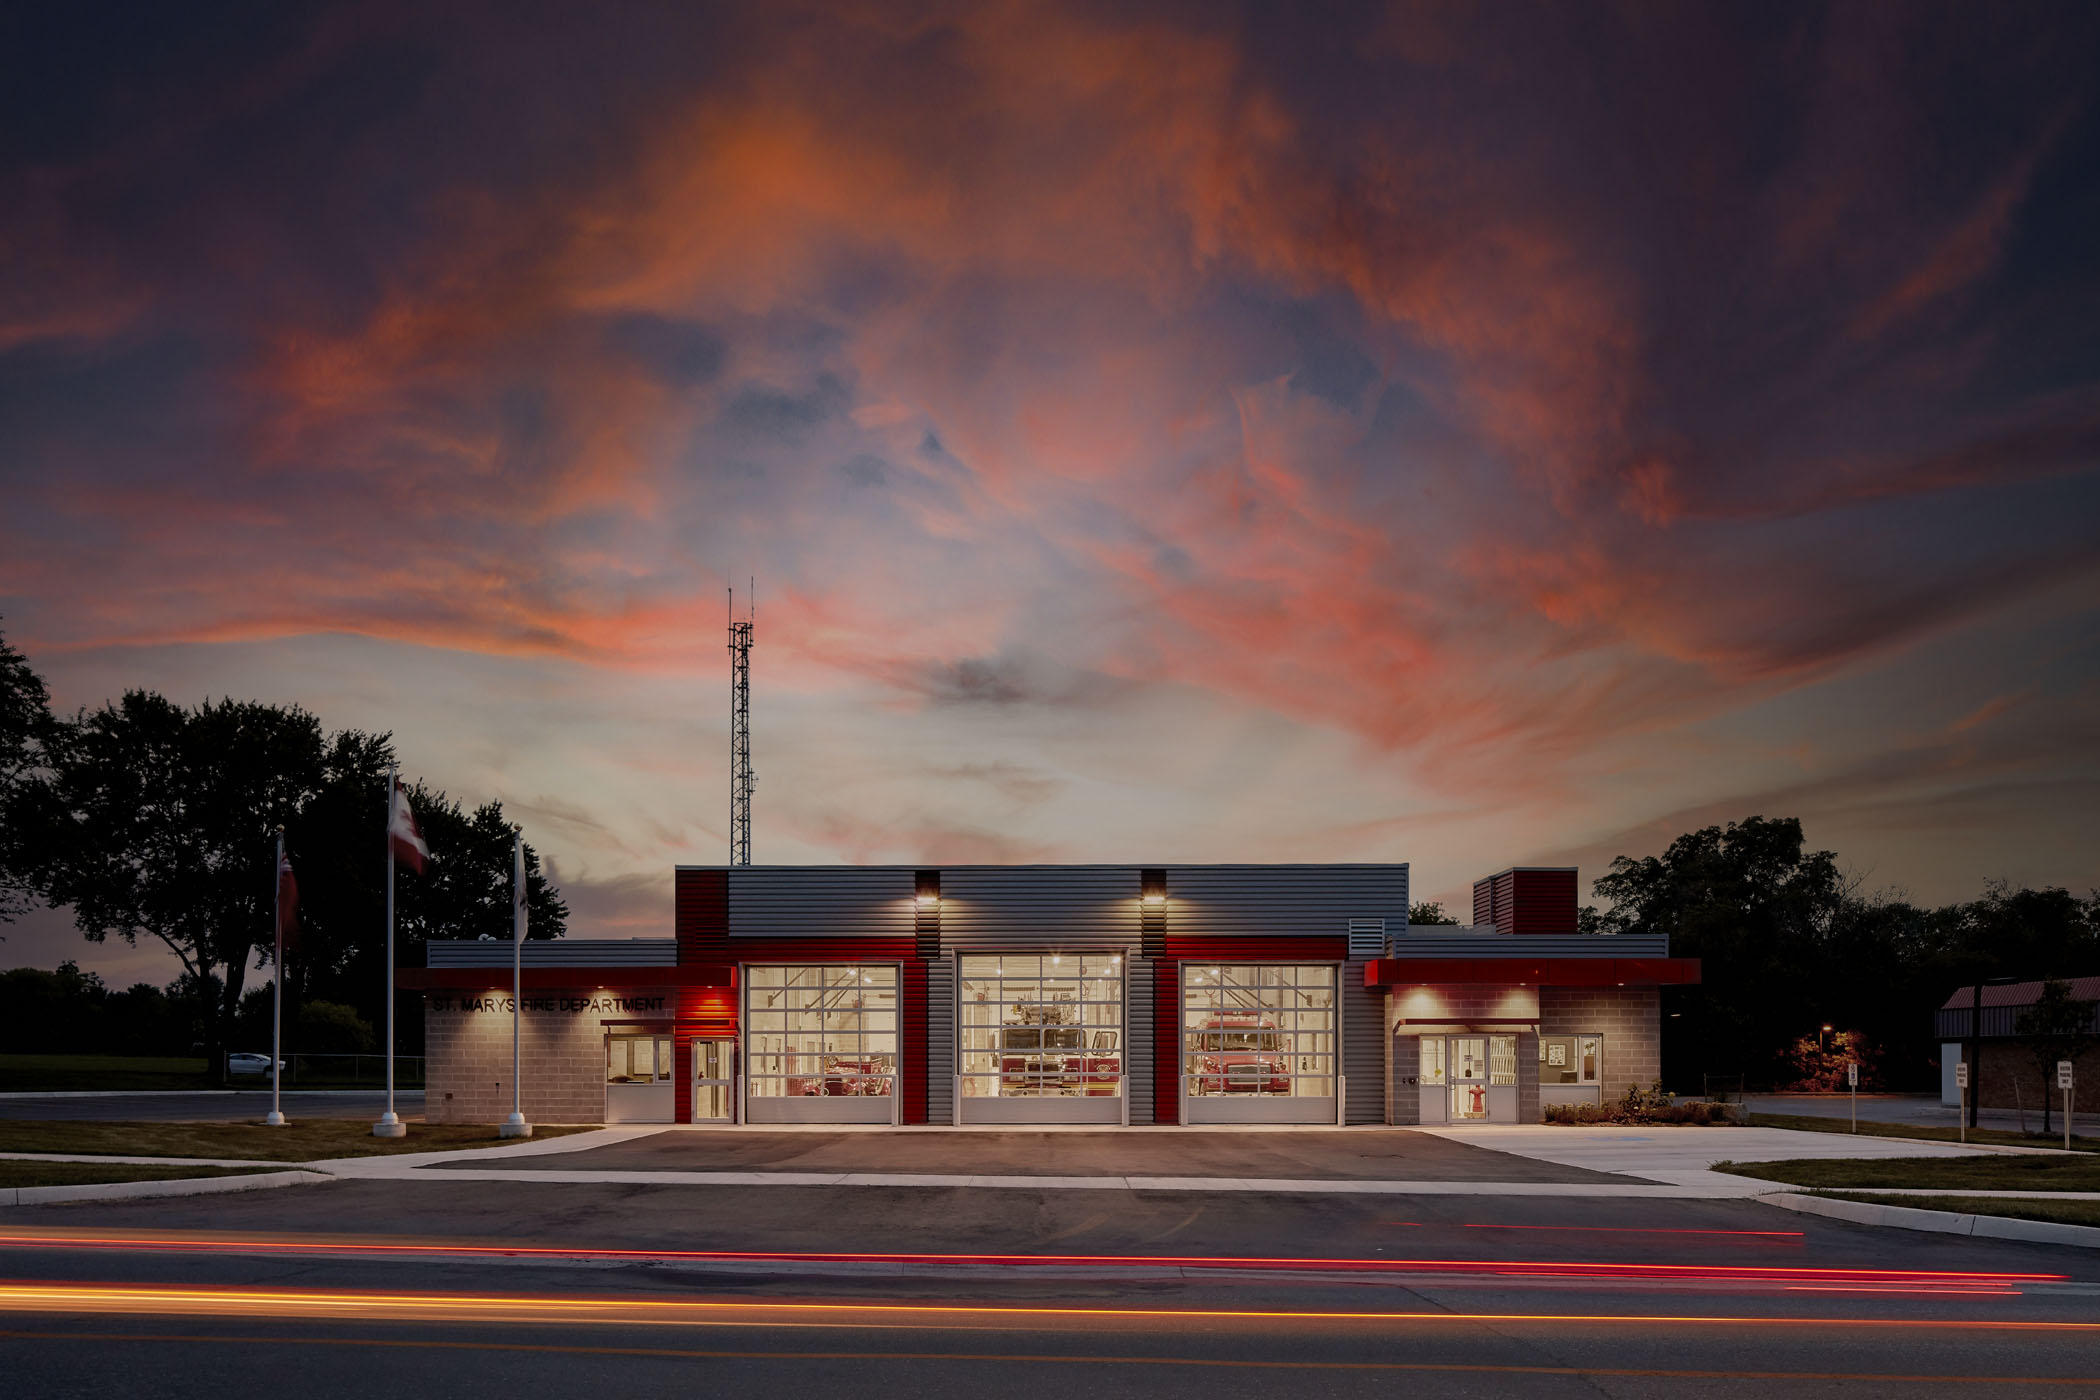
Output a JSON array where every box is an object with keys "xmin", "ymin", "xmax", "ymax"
[{"xmin": 46, "ymin": 691, "xmax": 567, "ymax": 1062}]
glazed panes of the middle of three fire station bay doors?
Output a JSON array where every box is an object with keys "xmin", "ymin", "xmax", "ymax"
[{"xmin": 956, "ymin": 953, "xmax": 1124, "ymax": 1098}]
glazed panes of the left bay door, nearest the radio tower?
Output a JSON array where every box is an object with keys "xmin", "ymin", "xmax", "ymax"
[{"xmin": 743, "ymin": 963, "xmax": 897, "ymax": 1098}]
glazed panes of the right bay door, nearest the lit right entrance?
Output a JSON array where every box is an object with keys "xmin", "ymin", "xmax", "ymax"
[{"xmin": 1182, "ymin": 963, "xmax": 1336, "ymax": 1098}]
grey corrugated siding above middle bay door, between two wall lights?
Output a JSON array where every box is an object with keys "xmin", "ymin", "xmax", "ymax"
[{"xmin": 941, "ymin": 865, "xmax": 1138, "ymax": 949}]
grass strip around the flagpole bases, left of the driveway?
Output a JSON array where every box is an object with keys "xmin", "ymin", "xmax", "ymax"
[{"xmin": 0, "ymin": 1119, "xmax": 588, "ymax": 1163}]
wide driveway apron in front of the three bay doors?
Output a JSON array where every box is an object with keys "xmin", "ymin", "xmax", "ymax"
[{"xmin": 315, "ymin": 1125, "xmax": 2015, "ymax": 1199}]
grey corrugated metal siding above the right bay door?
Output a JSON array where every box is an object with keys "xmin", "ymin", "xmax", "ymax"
[{"xmin": 1168, "ymin": 865, "xmax": 1407, "ymax": 938}]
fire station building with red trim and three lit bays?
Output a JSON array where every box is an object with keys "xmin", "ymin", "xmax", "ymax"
[{"xmin": 397, "ymin": 865, "xmax": 1699, "ymax": 1127}]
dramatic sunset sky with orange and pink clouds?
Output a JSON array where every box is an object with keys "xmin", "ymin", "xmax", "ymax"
[{"xmin": 0, "ymin": 0, "xmax": 2100, "ymax": 980}]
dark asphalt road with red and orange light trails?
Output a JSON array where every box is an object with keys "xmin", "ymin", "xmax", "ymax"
[{"xmin": 0, "ymin": 1182, "xmax": 2100, "ymax": 1400}]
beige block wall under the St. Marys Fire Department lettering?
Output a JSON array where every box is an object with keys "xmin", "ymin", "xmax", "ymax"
[{"xmin": 424, "ymin": 993, "xmax": 646, "ymax": 1123}]
